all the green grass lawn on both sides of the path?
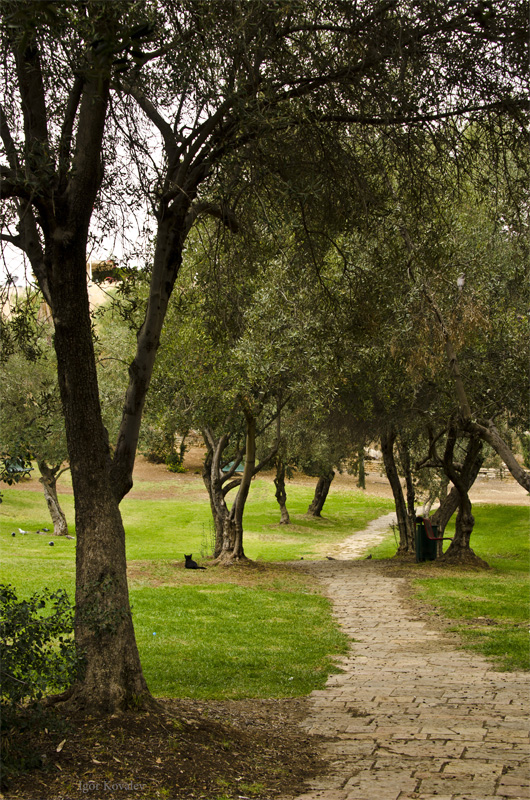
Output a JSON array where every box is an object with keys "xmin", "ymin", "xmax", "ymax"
[{"xmin": 0, "ymin": 479, "xmax": 529, "ymax": 699}]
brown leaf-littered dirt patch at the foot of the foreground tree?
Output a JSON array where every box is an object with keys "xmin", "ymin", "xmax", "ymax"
[{"xmin": 5, "ymin": 699, "xmax": 325, "ymax": 800}]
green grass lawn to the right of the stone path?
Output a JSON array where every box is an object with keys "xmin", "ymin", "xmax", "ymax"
[{"xmin": 372, "ymin": 505, "xmax": 530, "ymax": 670}]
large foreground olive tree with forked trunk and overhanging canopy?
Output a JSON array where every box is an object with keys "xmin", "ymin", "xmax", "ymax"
[{"xmin": 0, "ymin": 0, "xmax": 526, "ymax": 712}]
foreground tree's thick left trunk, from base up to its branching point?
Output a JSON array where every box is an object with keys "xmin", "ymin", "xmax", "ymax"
[{"xmin": 52, "ymin": 246, "xmax": 151, "ymax": 713}]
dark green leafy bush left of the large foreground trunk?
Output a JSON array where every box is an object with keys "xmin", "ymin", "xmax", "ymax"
[{"xmin": 0, "ymin": 584, "xmax": 80, "ymax": 705}]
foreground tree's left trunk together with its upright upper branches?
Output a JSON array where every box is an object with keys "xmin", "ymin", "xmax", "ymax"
[{"xmin": 6, "ymin": 36, "xmax": 154, "ymax": 714}]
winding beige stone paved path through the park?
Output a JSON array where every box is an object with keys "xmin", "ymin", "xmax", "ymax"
[{"xmin": 284, "ymin": 520, "xmax": 530, "ymax": 800}]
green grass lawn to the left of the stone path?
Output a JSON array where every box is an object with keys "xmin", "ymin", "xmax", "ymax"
[{"xmin": 0, "ymin": 479, "xmax": 392, "ymax": 699}]
